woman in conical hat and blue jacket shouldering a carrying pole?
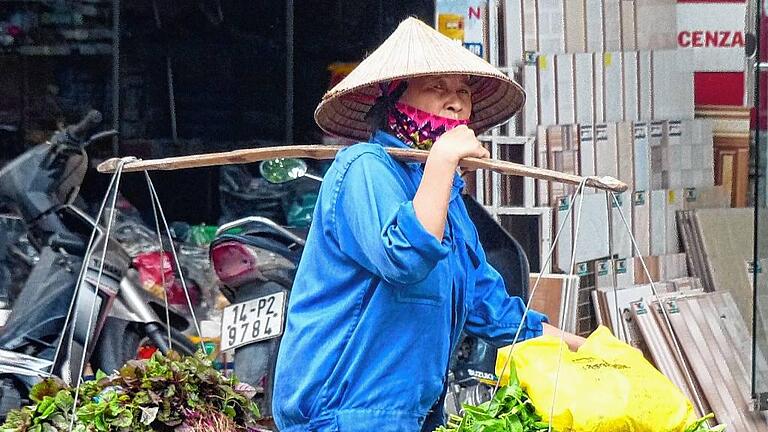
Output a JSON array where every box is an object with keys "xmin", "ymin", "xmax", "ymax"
[{"xmin": 273, "ymin": 18, "xmax": 583, "ymax": 432}]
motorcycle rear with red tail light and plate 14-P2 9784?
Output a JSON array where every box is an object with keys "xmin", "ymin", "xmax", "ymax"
[{"xmin": 210, "ymin": 216, "xmax": 304, "ymax": 419}]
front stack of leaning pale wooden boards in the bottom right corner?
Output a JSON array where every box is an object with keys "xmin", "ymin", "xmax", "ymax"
[{"xmin": 630, "ymin": 292, "xmax": 768, "ymax": 431}]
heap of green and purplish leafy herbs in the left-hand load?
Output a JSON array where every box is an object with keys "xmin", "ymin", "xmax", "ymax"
[{"xmin": 0, "ymin": 352, "xmax": 260, "ymax": 432}]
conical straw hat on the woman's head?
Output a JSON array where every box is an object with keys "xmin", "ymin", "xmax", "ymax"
[{"xmin": 315, "ymin": 18, "xmax": 525, "ymax": 140}]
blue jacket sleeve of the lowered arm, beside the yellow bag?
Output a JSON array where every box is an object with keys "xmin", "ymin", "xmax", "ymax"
[{"xmin": 465, "ymin": 244, "xmax": 548, "ymax": 347}]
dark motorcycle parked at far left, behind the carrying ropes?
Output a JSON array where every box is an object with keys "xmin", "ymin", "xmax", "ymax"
[{"xmin": 0, "ymin": 111, "xmax": 196, "ymax": 416}]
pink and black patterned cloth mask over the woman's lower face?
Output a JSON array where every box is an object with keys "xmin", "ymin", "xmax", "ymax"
[{"xmin": 387, "ymin": 102, "xmax": 469, "ymax": 150}]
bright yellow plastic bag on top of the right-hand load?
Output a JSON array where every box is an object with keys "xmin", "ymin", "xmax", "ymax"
[{"xmin": 496, "ymin": 327, "xmax": 696, "ymax": 432}]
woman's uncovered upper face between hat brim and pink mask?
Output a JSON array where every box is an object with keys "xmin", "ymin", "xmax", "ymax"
[{"xmin": 400, "ymin": 75, "xmax": 472, "ymax": 120}]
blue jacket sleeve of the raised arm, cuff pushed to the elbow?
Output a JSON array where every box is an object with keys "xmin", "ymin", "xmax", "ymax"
[{"xmin": 332, "ymin": 151, "xmax": 449, "ymax": 285}]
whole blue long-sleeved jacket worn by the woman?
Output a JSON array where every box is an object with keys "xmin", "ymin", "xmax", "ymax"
[{"xmin": 273, "ymin": 131, "xmax": 546, "ymax": 432}]
